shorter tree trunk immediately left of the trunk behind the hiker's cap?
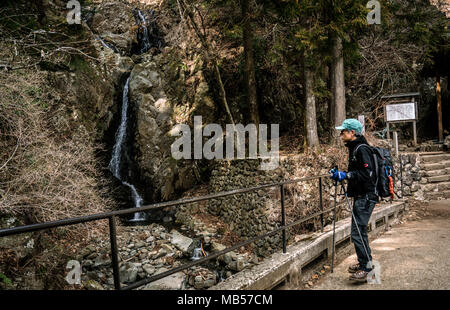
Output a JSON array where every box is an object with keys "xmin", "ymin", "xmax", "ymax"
[{"xmin": 303, "ymin": 65, "xmax": 319, "ymax": 147}]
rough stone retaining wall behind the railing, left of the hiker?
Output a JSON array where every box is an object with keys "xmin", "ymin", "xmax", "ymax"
[{"xmin": 177, "ymin": 154, "xmax": 348, "ymax": 256}]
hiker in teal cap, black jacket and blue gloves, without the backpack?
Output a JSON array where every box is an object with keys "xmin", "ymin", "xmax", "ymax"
[{"xmin": 331, "ymin": 119, "xmax": 379, "ymax": 282}]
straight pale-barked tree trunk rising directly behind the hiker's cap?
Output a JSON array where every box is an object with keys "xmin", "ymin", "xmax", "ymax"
[{"xmin": 331, "ymin": 35, "xmax": 346, "ymax": 142}]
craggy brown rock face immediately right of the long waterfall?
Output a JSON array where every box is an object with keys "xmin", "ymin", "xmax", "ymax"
[{"xmin": 130, "ymin": 47, "xmax": 215, "ymax": 201}]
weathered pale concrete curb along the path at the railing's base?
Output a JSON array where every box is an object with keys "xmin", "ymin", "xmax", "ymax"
[{"xmin": 210, "ymin": 201, "xmax": 406, "ymax": 290}]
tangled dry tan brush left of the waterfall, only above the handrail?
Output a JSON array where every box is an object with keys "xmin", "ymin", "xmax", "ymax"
[{"xmin": 0, "ymin": 67, "xmax": 111, "ymax": 222}]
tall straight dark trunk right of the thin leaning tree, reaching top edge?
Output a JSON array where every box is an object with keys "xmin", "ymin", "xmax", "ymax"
[{"xmin": 241, "ymin": 0, "xmax": 259, "ymax": 126}]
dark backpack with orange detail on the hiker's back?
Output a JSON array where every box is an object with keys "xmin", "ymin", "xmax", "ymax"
[{"xmin": 353, "ymin": 144, "xmax": 394, "ymax": 199}]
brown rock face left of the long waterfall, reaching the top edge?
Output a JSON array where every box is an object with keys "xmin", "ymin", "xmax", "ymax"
[{"xmin": 48, "ymin": 1, "xmax": 141, "ymax": 140}]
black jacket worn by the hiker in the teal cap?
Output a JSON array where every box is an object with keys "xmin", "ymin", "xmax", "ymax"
[{"xmin": 345, "ymin": 136, "xmax": 378, "ymax": 201}]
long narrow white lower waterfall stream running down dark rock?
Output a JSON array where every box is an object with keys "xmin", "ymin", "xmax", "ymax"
[{"xmin": 109, "ymin": 78, "xmax": 147, "ymax": 222}]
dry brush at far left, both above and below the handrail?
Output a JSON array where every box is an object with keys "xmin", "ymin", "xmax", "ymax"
[{"xmin": 0, "ymin": 55, "xmax": 113, "ymax": 288}]
